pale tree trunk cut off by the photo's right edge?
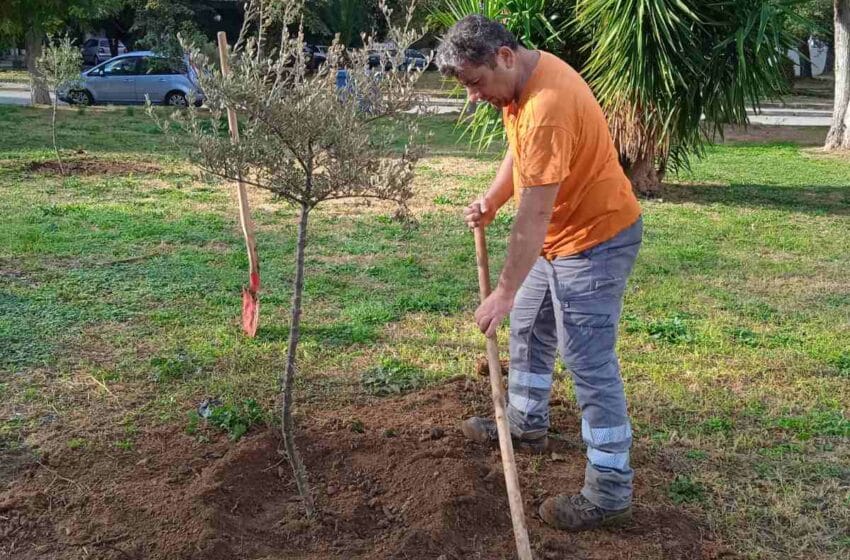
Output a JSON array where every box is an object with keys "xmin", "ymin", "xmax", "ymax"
[{"xmin": 824, "ymin": 0, "xmax": 850, "ymax": 150}]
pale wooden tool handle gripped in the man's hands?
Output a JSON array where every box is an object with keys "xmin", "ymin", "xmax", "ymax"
[{"xmin": 473, "ymin": 227, "xmax": 532, "ymax": 560}]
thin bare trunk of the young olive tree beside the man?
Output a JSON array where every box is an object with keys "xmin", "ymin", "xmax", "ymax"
[{"xmin": 281, "ymin": 203, "xmax": 316, "ymax": 518}]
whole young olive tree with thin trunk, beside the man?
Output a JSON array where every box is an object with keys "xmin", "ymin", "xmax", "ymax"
[{"xmin": 151, "ymin": 0, "xmax": 422, "ymax": 517}]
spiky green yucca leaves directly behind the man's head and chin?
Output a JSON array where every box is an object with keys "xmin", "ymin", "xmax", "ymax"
[{"xmin": 428, "ymin": 0, "xmax": 574, "ymax": 149}]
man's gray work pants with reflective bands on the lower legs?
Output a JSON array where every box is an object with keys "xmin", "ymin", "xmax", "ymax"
[{"xmin": 507, "ymin": 219, "xmax": 643, "ymax": 509}]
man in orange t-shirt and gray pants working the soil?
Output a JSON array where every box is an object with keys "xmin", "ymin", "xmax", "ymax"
[{"xmin": 437, "ymin": 15, "xmax": 642, "ymax": 530}]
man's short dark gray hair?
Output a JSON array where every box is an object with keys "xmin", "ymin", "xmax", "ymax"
[{"xmin": 436, "ymin": 15, "xmax": 519, "ymax": 77}]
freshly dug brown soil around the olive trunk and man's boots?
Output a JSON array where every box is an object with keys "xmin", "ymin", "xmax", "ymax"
[{"xmin": 0, "ymin": 379, "xmax": 730, "ymax": 560}]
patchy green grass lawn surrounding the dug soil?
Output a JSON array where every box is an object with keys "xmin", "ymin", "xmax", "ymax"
[{"xmin": 0, "ymin": 107, "xmax": 850, "ymax": 559}]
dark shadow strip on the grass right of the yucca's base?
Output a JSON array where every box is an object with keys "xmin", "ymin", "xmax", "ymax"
[{"xmin": 658, "ymin": 183, "xmax": 850, "ymax": 216}]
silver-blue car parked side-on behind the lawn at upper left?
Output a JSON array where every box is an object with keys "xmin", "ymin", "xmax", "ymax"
[{"xmin": 59, "ymin": 51, "xmax": 203, "ymax": 107}]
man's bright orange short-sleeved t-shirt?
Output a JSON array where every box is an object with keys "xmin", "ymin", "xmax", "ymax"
[{"xmin": 502, "ymin": 51, "xmax": 640, "ymax": 259}]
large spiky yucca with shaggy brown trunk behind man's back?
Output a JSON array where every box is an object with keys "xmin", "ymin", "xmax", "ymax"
[{"xmin": 575, "ymin": 0, "xmax": 796, "ymax": 194}]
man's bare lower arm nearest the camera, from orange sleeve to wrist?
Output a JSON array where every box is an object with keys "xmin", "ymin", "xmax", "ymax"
[{"xmin": 498, "ymin": 184, "xmax": 558, "ymax": 294}]
